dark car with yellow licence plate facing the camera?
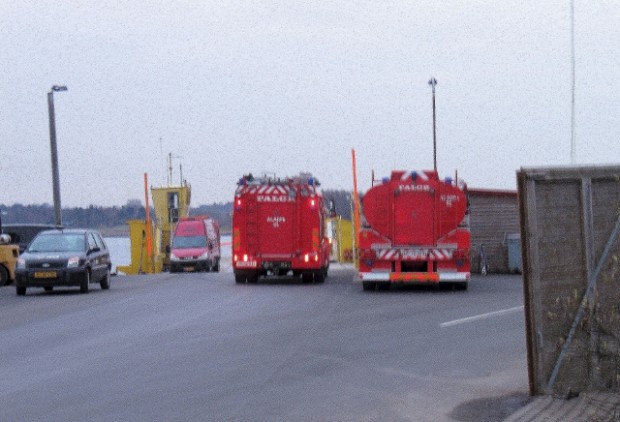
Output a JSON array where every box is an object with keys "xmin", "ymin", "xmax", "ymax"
[{"xmin": 15, "ymin": 229, "xmax": 112, "ymax": 296}]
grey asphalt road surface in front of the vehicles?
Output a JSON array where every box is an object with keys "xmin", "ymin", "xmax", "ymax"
[{"xmin": 0, "ymin": 265, "xmax": 528, "ymax": 421}]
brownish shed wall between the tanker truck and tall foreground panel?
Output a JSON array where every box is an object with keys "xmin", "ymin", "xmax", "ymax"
[{"xmin": 468, "ymin": 189, "xmax": 519, "ymax": 273}]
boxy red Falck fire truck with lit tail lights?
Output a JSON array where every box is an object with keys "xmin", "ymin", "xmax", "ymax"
[{"xmin": 232, "ymin": 173, "xmax": 329, "ymax": 283}]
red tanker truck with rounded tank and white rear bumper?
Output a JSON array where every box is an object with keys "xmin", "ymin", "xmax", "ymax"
[{"xmin": 359, "ymin": 171, "xmax": 471, "ymax": 290}]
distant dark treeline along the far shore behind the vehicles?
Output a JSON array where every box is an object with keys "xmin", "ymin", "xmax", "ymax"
[{"xmin": 0, "ymin": 190, "xmax": 352, "ymax": 232}]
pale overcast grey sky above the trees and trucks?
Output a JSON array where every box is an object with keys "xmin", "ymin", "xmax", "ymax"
[{"xmin": 0, "ymin": 0, "xmax": 620, "ymax": 207}]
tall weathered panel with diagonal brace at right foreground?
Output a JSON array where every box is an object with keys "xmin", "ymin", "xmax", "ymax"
[{"xmin": 518, "ymin": 167, "xmax": 620, "ymax": 395}]
